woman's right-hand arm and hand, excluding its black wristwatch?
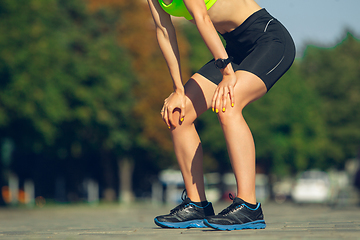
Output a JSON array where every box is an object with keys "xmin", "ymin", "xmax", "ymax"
[{"xmin": 183, "ymin": 0, "xmax": 236, "ymax": 111}]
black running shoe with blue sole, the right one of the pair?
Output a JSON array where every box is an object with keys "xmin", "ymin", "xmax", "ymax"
[{"xmin": 204, "ymin": 194, "xmax": 266, "ymax": 230}]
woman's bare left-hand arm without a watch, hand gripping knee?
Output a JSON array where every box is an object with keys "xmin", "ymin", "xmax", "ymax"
[{"xmin": 148, "ymin": 0, "xmax": 186, "ymax": 128}]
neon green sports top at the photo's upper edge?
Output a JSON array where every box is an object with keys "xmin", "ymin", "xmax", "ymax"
[{"xmin": 159, "ymin": 0, "xmax": 217, "ymax": 20}]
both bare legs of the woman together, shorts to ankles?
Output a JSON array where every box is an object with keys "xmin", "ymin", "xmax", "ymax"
[{"xmin": 171, "ymin": 71, "xmax": 266, "ymax": 203}]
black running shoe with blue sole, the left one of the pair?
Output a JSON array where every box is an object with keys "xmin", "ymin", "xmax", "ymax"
[{"xmin": 154, "ymin": 190, "xmax": 214, "ymax": 228}]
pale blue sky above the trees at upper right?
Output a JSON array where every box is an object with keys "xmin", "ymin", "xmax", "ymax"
[{"xmin": 256, "ymin": 0, "xmax": 360, "ymax": 55}]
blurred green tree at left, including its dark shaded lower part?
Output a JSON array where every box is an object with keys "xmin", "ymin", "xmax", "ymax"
[{"xmin": 0, "ymin": 0, "xmax": 138, "ymax": 201}]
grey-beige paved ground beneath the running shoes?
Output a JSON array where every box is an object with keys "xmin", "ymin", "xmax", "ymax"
[{"xmin": 0, "ymin": 203, "xmax": 360, "ymax": 240}]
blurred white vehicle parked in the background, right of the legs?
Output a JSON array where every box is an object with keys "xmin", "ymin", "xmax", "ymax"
[{"xmin": 291, "ymin": 170, "xmax": 330, "ymax": 203}]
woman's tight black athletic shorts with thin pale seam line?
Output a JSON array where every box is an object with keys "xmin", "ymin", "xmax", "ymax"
[{"xmin": 198, "ymin": 9, "xmax": 295, "ymax": 91}]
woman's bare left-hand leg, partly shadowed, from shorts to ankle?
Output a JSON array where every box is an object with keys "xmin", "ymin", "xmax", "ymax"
[{"xmin": 171, "ymin": 74, "xmax": 216, "ymax": 202}]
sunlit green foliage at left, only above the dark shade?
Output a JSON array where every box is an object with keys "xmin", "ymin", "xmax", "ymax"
[{"xmin": 0, "ymin": 0, "xmax": 134, "ymax": 154}]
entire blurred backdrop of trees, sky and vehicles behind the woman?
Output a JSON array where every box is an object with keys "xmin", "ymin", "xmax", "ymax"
[{"xmin": 0, "ymin": 0, "xmax": 360, "ymax": 207}]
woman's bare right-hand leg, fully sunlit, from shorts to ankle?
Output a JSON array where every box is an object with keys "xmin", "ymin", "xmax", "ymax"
[{"xmin": 218, "ymin": 71, "xmax": 266, "ymax": 204}]
